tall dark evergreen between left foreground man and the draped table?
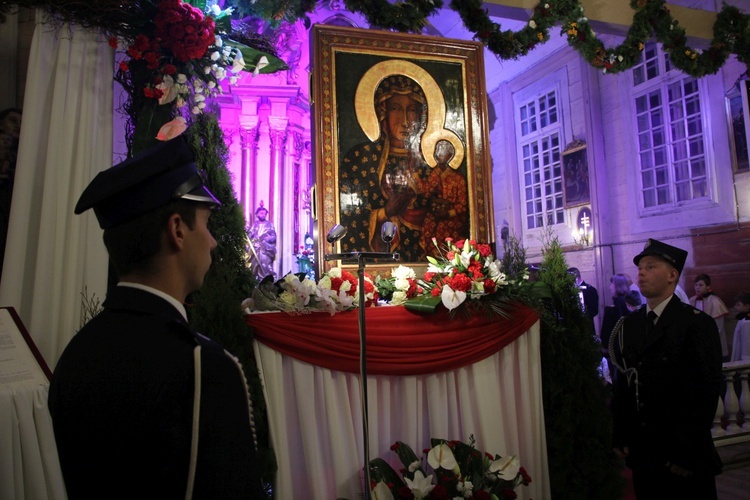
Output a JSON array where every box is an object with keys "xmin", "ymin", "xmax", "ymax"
[{"xmin": 185, "ymin": 113, "xmax": 276, "ymax": 492}]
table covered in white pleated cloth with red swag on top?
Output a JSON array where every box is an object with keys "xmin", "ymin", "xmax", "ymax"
[{"xmin": 247, "ymin": 306, "xmax": 549, "ymax": 500}]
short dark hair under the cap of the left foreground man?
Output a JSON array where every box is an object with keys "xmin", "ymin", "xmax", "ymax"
[{"xmin": 104, "ymin": 199, "xmax": 200, "ymax": 276}]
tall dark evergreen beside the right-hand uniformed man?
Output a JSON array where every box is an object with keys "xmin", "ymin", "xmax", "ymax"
[{"xmin": 539, "ymin": 237, "xmax": 623, "ymax": 500}]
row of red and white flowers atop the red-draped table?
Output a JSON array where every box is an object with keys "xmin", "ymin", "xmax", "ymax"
[{"xmin": 242, "ymin": 238, "xmax": 544, "ymax": 316}]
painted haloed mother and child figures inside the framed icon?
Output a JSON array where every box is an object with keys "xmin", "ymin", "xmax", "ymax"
[{"xmin": 338, "ymin": 60, "xmax": 470, "ymax": 262}]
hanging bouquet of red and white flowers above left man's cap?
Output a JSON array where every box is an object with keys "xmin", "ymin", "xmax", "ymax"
[{"xmin": 109, "ymin": 0, "xmax": 286, "ymax": 152}]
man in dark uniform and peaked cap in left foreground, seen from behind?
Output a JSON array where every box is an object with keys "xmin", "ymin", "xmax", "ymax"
[{"xmin": 49, "ymin": 137, "xmax": 265, "ymax": 500}]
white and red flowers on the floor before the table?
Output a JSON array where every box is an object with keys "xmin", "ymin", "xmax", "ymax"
[{"xmin": 370, "ymin": 436, "xmax": 531, "ymax": 500}]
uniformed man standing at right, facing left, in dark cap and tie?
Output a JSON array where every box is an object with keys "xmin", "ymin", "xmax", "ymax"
[{"xmin": 611, "ymin": 239, "xmax": 722, "ymax": 500}]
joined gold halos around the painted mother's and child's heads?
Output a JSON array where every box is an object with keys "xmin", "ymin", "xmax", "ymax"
[{"xmin": 354, "ymin": 59, "xmax": 464, "ymax": 168}]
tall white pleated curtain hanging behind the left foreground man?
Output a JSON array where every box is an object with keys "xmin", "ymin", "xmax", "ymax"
[{"xmin": 0, "ymin": 13, "xmax": 113, "ymax": 368}]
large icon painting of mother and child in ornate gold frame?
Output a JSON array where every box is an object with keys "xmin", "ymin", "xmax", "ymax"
[{"xmin": 312, "ymin": 25, "xmax": 494, "ymax": 273}]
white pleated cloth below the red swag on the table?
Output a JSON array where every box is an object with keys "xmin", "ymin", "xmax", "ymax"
[{"xmin": 254, "ymin": 321, "xmax": 550, "ymax": 500}]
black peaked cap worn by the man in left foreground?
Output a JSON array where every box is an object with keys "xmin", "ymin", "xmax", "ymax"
[{"xmin": 75, "ymin": 136, "xmax": 221, "ymax": 229}]
